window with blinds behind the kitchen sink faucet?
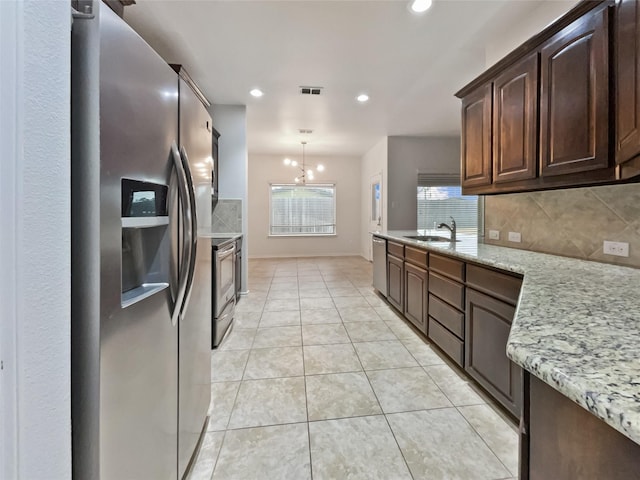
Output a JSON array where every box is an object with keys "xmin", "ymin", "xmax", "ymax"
[{"xmin": 418, "ymin": 174, "xmax": 482, "ymax": 234}]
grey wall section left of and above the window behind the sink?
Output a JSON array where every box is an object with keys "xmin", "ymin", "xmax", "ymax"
[{"xmin": 387, "ymin": 136, "xmax": 460, "ymax": 230}]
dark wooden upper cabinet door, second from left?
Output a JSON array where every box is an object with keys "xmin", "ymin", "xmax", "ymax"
[{"xmin": 493, "ymin": 52, "xmax": 538, "ymax": 183}]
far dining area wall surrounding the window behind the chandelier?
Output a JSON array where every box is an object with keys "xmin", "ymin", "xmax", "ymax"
[{"xmin": 249, "ymin": 155, "xmax": 361, "ymax": 257}]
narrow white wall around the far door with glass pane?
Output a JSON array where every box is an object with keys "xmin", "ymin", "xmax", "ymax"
[{"xmin": 360, "ymin": 137, "xmax": 388, "ymax": 260}]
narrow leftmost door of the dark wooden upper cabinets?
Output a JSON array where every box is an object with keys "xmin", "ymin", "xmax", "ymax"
[{"xmin": 461, "ymin": 84, "xmax": 492, "ymax": 188}]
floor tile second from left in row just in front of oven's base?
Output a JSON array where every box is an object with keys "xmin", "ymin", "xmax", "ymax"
[{"xmin": 243, "ymin": 347, "xmax": 304, "ymax": 380}]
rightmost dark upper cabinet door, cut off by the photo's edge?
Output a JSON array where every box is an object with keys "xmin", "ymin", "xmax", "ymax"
[{"xmin": 615, "ymin": 0, "xmax": 640, "ymax": 164}]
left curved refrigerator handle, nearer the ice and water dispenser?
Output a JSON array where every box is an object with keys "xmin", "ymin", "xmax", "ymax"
[{"xmin": 171, "ymin": 141, "xmax": 192, "ymax": 326}]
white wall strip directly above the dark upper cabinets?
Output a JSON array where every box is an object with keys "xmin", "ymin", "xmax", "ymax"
[{"xmin": 485, "ymin": 0, "xmax": 577, "ymax": 68}]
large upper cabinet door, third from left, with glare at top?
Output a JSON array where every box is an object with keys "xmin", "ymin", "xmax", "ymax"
[{"xmin": 540, "ymin": 9, "xmax": 609, "ymax": 177}]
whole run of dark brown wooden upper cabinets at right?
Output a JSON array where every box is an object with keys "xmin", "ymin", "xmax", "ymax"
[{"xmin": 456, "ymin": 0, "xmax": 640, "ymax": 194}]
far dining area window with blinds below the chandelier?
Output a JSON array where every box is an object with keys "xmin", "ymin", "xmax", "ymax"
[{"xmin": 269, "ymin": 184, "xmax": 336, "ymax": 236}]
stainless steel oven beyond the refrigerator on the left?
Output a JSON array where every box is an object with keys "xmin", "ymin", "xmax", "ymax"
[{"xmin": 211, "ymin": 239, "xmax": 236, "ymax": 348}]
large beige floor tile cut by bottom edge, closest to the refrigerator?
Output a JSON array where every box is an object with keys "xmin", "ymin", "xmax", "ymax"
[{"xmin": 213, "ymin": 423, "xmax": 311, "ymax": 480}]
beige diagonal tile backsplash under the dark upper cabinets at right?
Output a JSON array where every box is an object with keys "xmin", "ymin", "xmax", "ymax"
[{"xmin": 484, "ymin": 184, "xmax": 640, "ymax": 268}]
